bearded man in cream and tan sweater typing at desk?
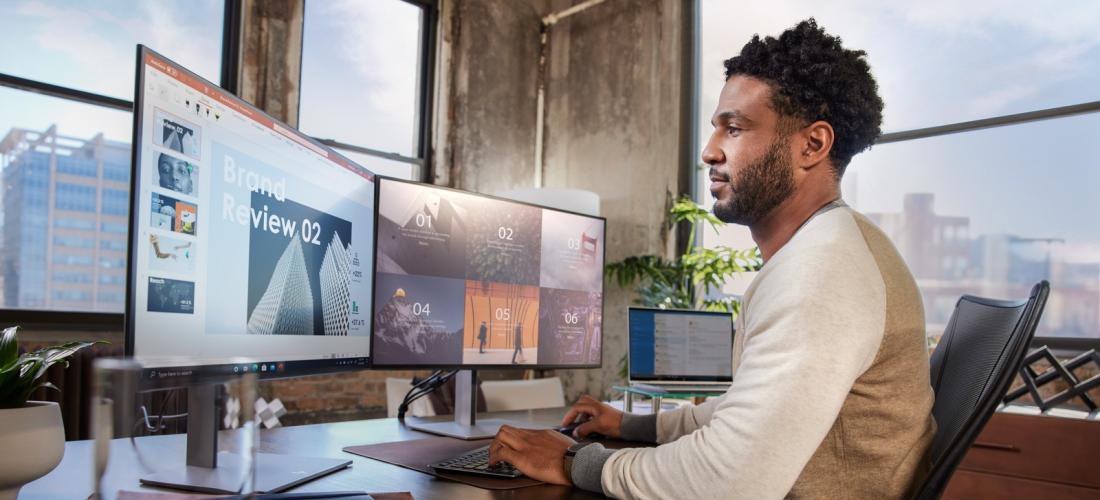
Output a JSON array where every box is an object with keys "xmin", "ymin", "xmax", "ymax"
[{"xmin": 490, "ymin": 19, "xmax": 935, "ymax": 499}]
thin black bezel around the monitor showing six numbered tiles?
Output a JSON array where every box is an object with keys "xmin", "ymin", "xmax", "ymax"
[{"xmin": 370, "ymin": 175, "xmax": 607, "ymax": 370}]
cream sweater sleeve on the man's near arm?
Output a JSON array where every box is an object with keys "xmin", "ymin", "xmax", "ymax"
[{"xmin": 601, "ymin": 241, "xmax": 886, "ymax": 499}]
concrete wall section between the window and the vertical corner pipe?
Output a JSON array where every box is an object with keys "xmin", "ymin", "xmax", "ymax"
[{"xmin": 433, "ymin": 0, "xmax": 540, "ymax": 193}]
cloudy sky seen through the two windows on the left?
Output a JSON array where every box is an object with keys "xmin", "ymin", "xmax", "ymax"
[{"xmin": 0, "ymin": 0, "xmax": 420, "ymax": 164}]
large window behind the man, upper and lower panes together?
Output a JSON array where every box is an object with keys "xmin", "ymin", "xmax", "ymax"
[{"xmin": 696, "ymin": 0, "xmax": 1100, "ymax": 340}]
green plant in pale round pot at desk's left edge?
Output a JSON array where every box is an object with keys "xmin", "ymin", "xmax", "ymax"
[{"xmin": 0, "ymin": 326, "xmax": 95, "ymax": 500}]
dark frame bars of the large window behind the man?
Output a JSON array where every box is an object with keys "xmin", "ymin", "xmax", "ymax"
[{"xmin": 678, "ymin": 0, "xmax": 1100, "ymax": 355}]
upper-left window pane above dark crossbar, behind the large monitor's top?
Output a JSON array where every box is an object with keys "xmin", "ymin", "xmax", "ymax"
[{"xmin": 0, "ymin": 0, "xmax": 224, "ymax": 100}]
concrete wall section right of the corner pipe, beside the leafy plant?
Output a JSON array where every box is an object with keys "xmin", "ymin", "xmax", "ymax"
[{"xmin": 543, "ymin": 0, "xmax": 690, "ymax": 397}]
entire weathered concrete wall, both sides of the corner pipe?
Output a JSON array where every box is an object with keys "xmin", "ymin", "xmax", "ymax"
[{"xmin": 437, "ymin": 0, "xmax": 690, "ymax": 400}]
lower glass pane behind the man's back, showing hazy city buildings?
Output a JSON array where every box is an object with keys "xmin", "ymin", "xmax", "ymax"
[{"xmin": 844, "ymin": 114, "xmax": 1100, "ymax": 338}]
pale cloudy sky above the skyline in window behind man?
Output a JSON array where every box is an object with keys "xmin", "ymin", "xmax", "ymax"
[{"xmin": 696, "ymin": 0, "xmax": 1100, "ymax": 262}]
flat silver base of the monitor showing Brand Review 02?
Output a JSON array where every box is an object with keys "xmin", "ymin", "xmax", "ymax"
[{"xmin": 141, "ymin": 453, "xmax": 351, "ymax": 495}]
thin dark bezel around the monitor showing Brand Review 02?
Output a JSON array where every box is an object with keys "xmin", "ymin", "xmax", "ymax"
[{"xmin": 123, "ymin": 44, "xmax": 378, "ymax": 389}]
